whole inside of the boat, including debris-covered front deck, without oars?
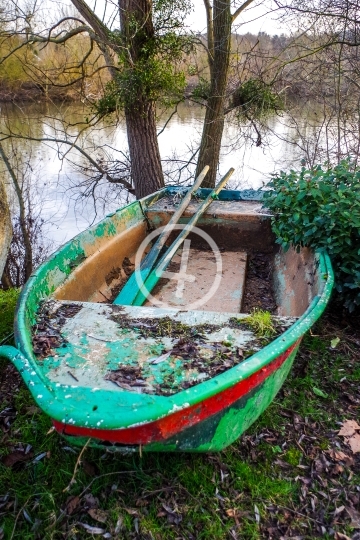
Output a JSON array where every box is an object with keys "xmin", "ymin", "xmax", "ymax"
[{"xmin": 28, "ymin": 188, "xmax": 321, "ymax": 396}]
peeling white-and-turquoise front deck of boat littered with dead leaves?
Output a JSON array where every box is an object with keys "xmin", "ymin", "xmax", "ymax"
[{"xmin": 33, "ymin": 300, "xmax": 295, "ymax": 396}]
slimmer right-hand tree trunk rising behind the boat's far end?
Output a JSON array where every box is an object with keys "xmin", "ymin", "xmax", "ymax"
[{"xmin": 196, "ymin": 0, "xmax": 232, "ymax": 187}]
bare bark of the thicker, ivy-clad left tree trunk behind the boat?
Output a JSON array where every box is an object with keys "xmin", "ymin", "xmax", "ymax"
[{"xmin": 119, "ymin": 0, "xmax": 164, "ymax": 199}]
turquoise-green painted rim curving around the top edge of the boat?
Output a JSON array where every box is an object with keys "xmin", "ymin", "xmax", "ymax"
[{"xmin": 0, "ymin": 187, "xmax": 334, "ymax": 429}]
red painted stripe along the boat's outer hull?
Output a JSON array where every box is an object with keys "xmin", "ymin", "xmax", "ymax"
[{"xmin": 53, "ymin": 339, "xmax": 301, "ymax": 444}]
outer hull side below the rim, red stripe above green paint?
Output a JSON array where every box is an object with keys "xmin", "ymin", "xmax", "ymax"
[{"xmin": 53, "ymin": 339, "xmax": 301, "ymax": 452}]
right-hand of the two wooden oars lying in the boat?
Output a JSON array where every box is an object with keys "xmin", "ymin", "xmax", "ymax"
[{"xmin": 132, "ymin": 168, "xmax": 235, "ymax": 306}]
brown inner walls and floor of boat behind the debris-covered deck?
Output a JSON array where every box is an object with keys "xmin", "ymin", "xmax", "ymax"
[{"xmin": 53, "ymin": 190, "xmax": 317, "ymax": 317}]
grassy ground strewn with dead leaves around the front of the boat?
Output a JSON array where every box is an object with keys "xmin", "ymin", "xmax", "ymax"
[{"xmin": 0, "ymin": 293, "xmax": 360, "ymax": 540}]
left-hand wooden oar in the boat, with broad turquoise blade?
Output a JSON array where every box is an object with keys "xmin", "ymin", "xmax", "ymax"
[{"xmin": 113, "ymin": 165, "xmax": 210, "ymax": 306}]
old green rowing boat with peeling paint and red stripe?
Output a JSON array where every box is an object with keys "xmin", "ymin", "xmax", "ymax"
[{"xmin": 0, "ymin": 186, "xmax": 333, "ymax": 453}]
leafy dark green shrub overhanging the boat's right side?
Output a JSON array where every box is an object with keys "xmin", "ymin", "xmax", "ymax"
[{"xmin": 264, "ymin": 159, "xmax": 360, "ymax": 311}]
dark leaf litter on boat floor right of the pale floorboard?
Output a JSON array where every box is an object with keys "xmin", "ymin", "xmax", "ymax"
[{"xmin": 241, "ymin": 253, "xmax": 277, "ymax": 313}]
